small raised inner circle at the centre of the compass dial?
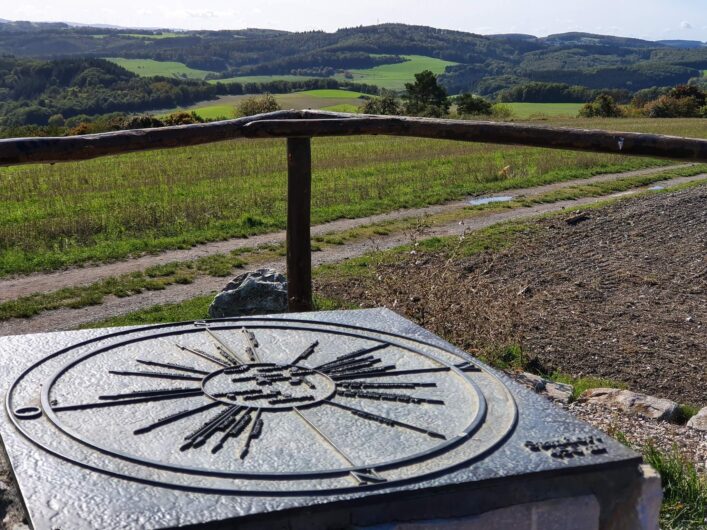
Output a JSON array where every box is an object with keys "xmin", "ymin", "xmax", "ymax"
[{"xmin": 201, "ymin": 363, "xmax": 336, "ymax": 411}]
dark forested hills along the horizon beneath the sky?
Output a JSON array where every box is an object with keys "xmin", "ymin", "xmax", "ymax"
[{"xmin": 0, "ymin": 22, "xmax": 707, "ymax": 95}]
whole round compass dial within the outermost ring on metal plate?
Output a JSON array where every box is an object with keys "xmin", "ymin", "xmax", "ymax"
[{"xmin": 7, "ymin": 318, "xmax": 515, "ymax": 492}]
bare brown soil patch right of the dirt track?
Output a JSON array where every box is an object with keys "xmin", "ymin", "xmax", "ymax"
[{"xmin": 317, "ymin": 186, "xmax": 707, "ymax": 405}]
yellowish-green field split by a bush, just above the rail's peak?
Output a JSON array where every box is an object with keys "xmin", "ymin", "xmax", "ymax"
[{"xmin": 158, "ymin": 90, "xmax": 365, "ymax": 120}]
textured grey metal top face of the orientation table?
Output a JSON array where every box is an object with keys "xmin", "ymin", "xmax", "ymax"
[{"xmin": 0, "ymin": 310, "xmax": 636, "ymax": 528}]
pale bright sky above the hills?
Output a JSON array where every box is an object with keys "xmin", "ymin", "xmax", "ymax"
[{"xmin": 0, "ymin": 0, "xmax": 707, "ymax": 41}]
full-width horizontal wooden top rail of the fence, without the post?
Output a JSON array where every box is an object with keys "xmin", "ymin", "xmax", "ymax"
[{"xmin": 0, "ymin": 110, "xmax": 707, "ymax": 166}]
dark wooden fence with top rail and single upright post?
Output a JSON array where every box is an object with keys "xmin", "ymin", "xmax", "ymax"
[{"xmin": 0, "ymin": 110, "xmax": 707, "ymax": 311}]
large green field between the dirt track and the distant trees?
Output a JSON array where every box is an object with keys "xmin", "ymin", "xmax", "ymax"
[{"xmin": 0, "ymin": 115, "xmax": 707, "ymax": 275}]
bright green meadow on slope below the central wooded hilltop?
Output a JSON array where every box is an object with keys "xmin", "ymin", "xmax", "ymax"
[{"xmin": 335, "ymin": 55, "xmax": 457, "ymax": 90}]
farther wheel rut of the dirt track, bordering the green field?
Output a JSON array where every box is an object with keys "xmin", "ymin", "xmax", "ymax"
[{"xmin": 0, "ymin": 164, "xmax": 693, "ymax": 302}]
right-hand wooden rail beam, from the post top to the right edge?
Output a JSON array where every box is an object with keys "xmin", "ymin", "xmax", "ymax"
[{"xmin": 243, "ymin": 116, "xmax": 707, "ymax": 163}]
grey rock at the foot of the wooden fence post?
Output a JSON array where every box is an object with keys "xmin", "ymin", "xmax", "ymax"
[{"xmin": 209, "ymin": 269, "xmax": 287, "ymax": 318}]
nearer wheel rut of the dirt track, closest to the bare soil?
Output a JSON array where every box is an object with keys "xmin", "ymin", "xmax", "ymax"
[{"xmin": 0, "ymin": 175, "xmax": 707, "ymax": 336}]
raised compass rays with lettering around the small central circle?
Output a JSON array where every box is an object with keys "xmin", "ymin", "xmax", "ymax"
[{"xmin": 53, "ymin": 327, "xmax": 468, "ymax": 484}]
